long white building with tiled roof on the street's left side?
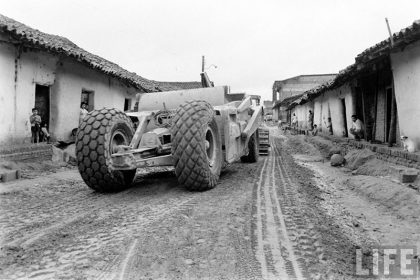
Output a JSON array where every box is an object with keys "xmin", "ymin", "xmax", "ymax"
[{"xmin": 0, "ymin": 15, "xmax": 201, "ymax": 145}]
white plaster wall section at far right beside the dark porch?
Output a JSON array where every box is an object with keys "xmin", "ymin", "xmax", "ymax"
[{"xmin": 391, "ymin": 42, "xmax": 420, "ymax": 150}]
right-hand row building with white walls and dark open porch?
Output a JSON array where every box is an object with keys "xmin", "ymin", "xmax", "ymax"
[{"xmin": 287, "ymin": 21, "xmax": 420, "ymax": 150}]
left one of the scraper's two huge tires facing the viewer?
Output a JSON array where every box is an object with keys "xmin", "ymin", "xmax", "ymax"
[{"xmin": 76, "ymin": 108, "xmax": 136, "ymax": 192}]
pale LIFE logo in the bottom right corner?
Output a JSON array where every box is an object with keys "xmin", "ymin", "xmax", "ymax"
[{"xmin": 355, "ymin": 246, "xmax": 418, "ymax": 279}]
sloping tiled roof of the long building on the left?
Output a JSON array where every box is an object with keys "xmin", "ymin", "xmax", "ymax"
[{"xmin": 0, "ymin": 14, "xmax": 201, "ymax": 92}]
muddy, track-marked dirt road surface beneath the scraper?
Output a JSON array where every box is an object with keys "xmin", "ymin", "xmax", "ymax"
[{"xmin": 0, "ymin": 132, "xmax": 360, "ymax": 279}]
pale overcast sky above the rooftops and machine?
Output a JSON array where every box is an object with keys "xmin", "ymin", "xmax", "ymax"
[{"xmin": 0, "ymin": 0, "xmax": 420, "ymax": 100}]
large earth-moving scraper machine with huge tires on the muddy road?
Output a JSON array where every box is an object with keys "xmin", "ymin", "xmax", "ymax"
[{"xmin": 76, "ymin": 73, "xmax": 263, "ymax": 192}]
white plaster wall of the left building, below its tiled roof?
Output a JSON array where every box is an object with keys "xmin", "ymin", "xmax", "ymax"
[{"xmin": 0, "ymin": 41, "xmax": 136, "ymax": 145}]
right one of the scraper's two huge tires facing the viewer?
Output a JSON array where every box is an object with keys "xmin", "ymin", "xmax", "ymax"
[{"xmin": 171, "ymin": 101, "xmax": 223, "ymax": 191}]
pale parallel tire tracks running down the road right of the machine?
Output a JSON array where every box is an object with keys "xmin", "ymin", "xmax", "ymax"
[{"xmin": 253, "ymin": 132, "xmax": 323, "ymax": 279}]
